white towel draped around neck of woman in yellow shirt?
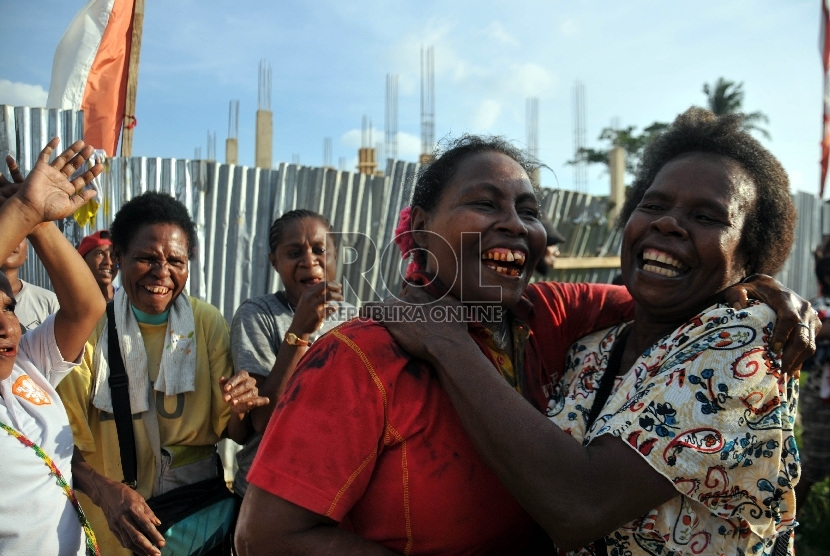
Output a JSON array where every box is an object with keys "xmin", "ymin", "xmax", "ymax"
[{"xmin": 92, "ymin": 288, "xmax": 196, "ymax": 414}]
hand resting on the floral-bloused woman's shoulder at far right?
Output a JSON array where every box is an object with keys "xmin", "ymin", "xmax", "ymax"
[{"xmin": 724, "ymin": 274, "xmax": 821, "ymax": 374}]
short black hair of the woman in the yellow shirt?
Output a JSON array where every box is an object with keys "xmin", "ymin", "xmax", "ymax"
[{"xmin": 110, "ymin": 191, "xmax": 197, "ymax": 259}]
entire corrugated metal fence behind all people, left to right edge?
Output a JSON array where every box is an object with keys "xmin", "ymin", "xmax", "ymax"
[{"xmin": 0, "ymin": 106, "xmax": 830, "ymax": 310}]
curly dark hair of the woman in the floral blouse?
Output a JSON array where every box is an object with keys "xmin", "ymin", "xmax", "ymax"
[{"xmin": 617, "ymin": 106, "xmax": 796, "ymax": 274}]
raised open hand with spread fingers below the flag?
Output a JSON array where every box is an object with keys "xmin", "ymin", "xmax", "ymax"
[{"xmin": 11, "ymin": 137, "xmax": 104, "ymax": 222}]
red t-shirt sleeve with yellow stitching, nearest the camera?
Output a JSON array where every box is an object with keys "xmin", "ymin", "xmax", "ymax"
[{"xmin": 248, "ymin": 333, "xmax": 385, "ymax": 521}]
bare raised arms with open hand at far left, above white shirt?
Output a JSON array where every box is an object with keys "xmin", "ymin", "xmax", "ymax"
[{"xmin": 0, "ymin": 138, "xmax": 105, "ymax": 361}]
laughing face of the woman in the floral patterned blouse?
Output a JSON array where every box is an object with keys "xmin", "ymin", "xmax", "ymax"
[{"xmin": 622, "ymin": 152, "xmax": 757, "ymax": 324}]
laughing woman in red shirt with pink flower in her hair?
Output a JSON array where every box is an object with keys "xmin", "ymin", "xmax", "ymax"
[{"xmin": 236, "ymin": 132, "xmax": 812, "ymax": 556}]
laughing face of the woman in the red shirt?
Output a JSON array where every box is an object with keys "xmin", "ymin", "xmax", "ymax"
[{"xmin": 412, "ymin": 152, "xmax": 546, "ymax": 308}]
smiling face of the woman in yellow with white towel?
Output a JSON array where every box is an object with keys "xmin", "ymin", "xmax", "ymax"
[{"xmin": 116, "ymin": 223, "xmax": 189, "ymax": 315}]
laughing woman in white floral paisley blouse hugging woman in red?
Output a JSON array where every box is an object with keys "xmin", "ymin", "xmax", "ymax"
[{"xmin": 387, "ymin": 108, "xmax": 813, "ymax": 555}]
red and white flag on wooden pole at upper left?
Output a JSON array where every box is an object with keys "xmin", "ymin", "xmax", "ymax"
[{"xmin": 46, "ymin": 0, "xmax": 134, "ymax": 156}]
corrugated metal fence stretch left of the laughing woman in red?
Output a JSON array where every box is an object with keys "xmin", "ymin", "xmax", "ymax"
[{"xmin": 0, "ymin": 106, "xmax": 419, "ymax": 312}]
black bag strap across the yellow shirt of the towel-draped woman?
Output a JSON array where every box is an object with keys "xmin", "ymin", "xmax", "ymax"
[{"xmin": 107, "ymin": 301, "xmax": 138, "ymax": 489}]
